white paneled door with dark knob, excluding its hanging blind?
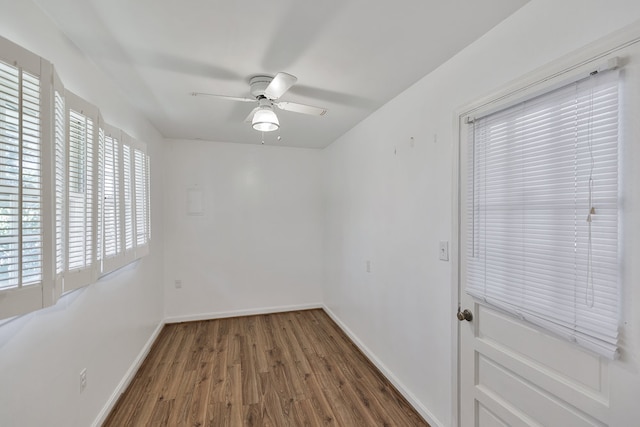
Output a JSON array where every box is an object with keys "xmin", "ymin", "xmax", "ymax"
[{"xmin": 458, "ymin": 30, "xmax": 640, "ymax": 427}]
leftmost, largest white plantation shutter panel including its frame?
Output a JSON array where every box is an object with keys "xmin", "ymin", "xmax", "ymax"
[{"xmin": 0, "ymin": 38, "xmax": 51, "ymax": 318}]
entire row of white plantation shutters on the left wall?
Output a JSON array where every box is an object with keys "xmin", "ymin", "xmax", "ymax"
[{"xmin": 0, "ymin": 37, "xmax": 150, "ymax": 319}]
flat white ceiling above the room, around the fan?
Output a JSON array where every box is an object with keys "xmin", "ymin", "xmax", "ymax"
[{"xmin": 36, "ymin": 0, "xmax": 528, "ymax": 148}]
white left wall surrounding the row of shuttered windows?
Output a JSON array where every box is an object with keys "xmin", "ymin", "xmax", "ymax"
[{"xmin": 0, "ymin": 0, "xmax": 164, "ymax": 427}]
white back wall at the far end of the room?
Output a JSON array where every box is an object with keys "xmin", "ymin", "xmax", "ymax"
[{"xmin": 163, "ymin": 140, "xmax": 323, "ymax": 321}]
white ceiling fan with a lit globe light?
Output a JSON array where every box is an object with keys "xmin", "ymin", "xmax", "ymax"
[{"xmin": 191, "ymin": 72, "xmax": 327, "ymax": 132}]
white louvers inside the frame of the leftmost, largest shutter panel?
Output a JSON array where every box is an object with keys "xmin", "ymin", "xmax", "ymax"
[{"xmin": 0, "ymin": 62, "xmax": 43, "ymax": 290}]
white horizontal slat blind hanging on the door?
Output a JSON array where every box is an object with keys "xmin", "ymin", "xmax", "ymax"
[{"xmin": 466, "ymin": 71, "xmax": 619, "ymax": 358}]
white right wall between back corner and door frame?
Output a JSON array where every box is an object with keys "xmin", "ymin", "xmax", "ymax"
[{"xmin": 323, "ymin": 0, "xmax": 640, "ymax": 426}]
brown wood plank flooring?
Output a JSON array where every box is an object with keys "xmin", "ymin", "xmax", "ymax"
[{"xmin": 104, "ymin": 310, "xmax": 428, "ymax": 427}]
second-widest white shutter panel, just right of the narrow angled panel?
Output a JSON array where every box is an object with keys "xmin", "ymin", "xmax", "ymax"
[{"xmin": 64, "ymin": 92, "xmax": 98, "ymax": 291}]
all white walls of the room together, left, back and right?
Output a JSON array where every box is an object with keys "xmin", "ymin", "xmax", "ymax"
[{"xmin": 0, "ymin": 0, "xmax": 640, "ymax": 426}]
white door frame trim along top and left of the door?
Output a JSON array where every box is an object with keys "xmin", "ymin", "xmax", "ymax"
[{"xmin": 449, "ymin": 23, "xmax": 640, "ymax": 426}]
